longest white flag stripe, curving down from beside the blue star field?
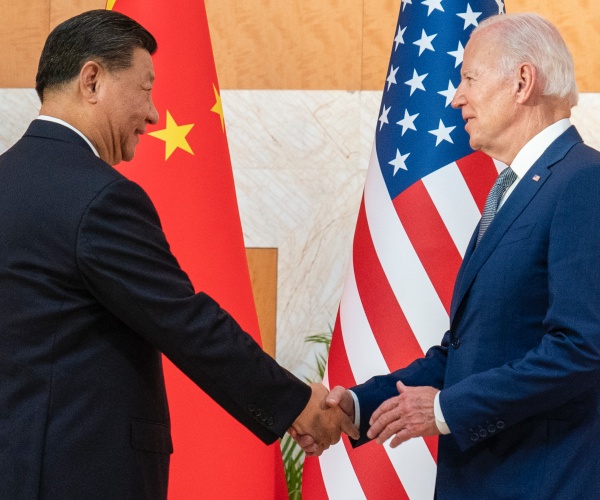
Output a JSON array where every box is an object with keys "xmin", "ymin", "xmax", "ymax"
[{"xmin": 365, "ymin": 148, "xmax": 448, "ymax": 352}]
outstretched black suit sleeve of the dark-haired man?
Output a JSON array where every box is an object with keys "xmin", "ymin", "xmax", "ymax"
[{"xmin": 77, "ymin": 180, "xmax": 310, "ymax": 443}]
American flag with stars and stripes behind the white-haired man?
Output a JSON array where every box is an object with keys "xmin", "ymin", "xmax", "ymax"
[{"xmin": 303, "ymin": 0, "xmax": 504, "ymax": 500}]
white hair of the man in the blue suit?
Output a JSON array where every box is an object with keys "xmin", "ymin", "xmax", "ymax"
[{"xmin": 471, "ymin": 13, "xmax": 579, "ymax": 106}]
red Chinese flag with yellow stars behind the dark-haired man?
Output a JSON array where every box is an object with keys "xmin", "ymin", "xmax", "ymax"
[{"xmin": 107, "ymin": 0, "xmax": 287, "ymax": 500}]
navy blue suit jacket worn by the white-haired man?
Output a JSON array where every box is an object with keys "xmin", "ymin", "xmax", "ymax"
[{"xmin": 354, "ymin": 127, "xmax": 600, "ymax": 500}]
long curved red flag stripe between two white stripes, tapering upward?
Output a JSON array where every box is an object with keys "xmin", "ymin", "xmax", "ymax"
[{"xmin": 353, "ymin": 199, "xmax": 423, "ymax": 371}]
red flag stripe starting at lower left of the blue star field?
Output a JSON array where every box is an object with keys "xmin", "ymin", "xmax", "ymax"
[{"xmin": 393, "ymin": 181, "xmax": 462, "ymax": 314}]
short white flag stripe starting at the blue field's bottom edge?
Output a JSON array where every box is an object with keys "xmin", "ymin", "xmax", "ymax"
[{"xmin": 423, "ymin": 162, "xmax": 481, "ymax": 257}]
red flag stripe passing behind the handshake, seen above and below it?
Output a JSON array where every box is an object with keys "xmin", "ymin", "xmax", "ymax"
[{"xmin": 324, "ymin": 314, "xmax": 408, "ymax": 499}]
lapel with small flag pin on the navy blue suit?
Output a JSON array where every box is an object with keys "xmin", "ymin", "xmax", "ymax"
[{"xmin": 450, "ymin": 126, "xmax": 582, "ymax": 321}]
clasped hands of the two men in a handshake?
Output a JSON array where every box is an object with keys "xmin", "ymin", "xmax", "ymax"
[{"xmin": 288, "ymin": 384, "xmax": 359, "ymax": 457}]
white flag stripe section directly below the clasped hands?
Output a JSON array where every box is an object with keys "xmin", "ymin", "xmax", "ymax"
[{"xmin": 319, "ymin": 440, "xmax": 367, "ymax": 500}]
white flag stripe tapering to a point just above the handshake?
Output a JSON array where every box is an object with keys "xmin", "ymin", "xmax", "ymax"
[{"xmin": 340, "ymin": 262, "xmax": 390, "ymax": 384}]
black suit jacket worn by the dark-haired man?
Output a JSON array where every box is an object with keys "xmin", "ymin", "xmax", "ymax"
[{"xmin": 0, "ymin": 120, "xmax": 310, "ymax": 500}]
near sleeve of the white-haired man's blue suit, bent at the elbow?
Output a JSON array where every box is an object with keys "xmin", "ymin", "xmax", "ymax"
[{"xmin": 440, "ymin": 165, "xmax": 600, "ymax": 450}]
